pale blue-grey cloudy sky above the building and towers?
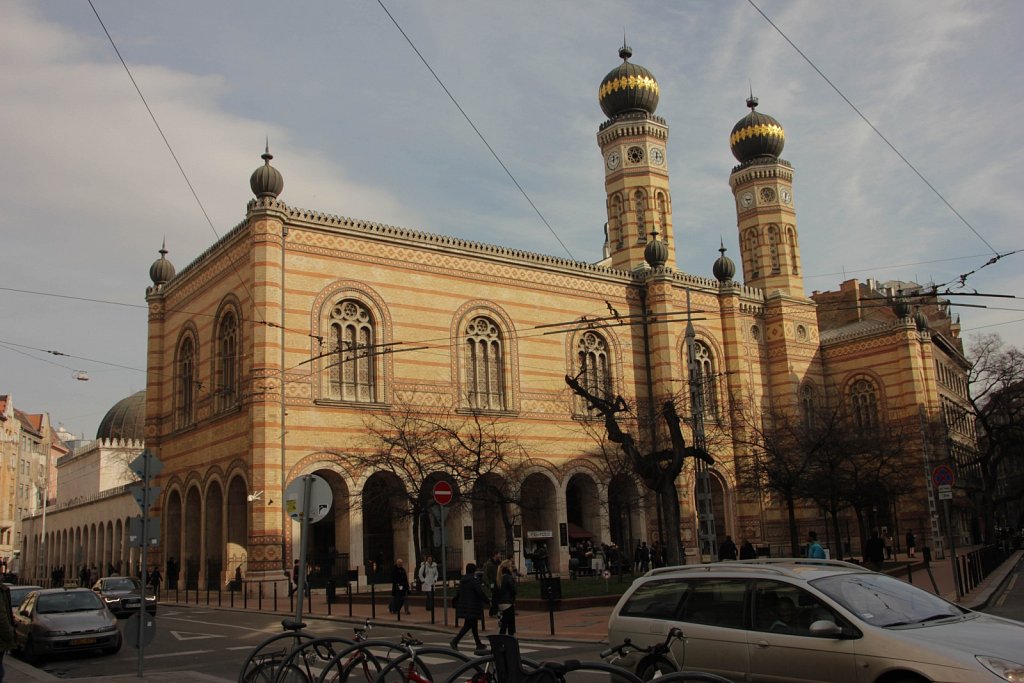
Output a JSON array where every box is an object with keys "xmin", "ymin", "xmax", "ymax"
[{"xmin": 0, "ymin": 0, "xmax": 1024, "ymax": 437}]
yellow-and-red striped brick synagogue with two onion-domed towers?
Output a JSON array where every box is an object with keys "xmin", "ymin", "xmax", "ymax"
[{"xmin": 19, "ymin": 47, "xmax": 972, "ymax": 588}]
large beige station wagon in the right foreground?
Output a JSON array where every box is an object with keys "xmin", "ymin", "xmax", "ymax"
[{"xmin": 608, "ymin": 559, "xmax": 1024, "ymax": 683}]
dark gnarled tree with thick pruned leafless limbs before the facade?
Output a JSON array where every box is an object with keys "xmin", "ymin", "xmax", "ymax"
[{"xmin": 565, "ymin": 375, "xmax": 712, "ymax": 564}]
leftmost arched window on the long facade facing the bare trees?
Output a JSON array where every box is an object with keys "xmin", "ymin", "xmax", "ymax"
[{"xmin": 328, "ymin": 299, "xmax": 377, "ymax": 403}]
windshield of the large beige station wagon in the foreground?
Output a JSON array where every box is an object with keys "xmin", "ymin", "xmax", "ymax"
[{"xmin": 812, "ymin": 573, "xmax": 967, "ymax": 627}]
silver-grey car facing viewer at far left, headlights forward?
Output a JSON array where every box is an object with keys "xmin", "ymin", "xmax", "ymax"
[{"xmin": 14, "ymin": 588, "xmax": 121, "ymax": 661}]
